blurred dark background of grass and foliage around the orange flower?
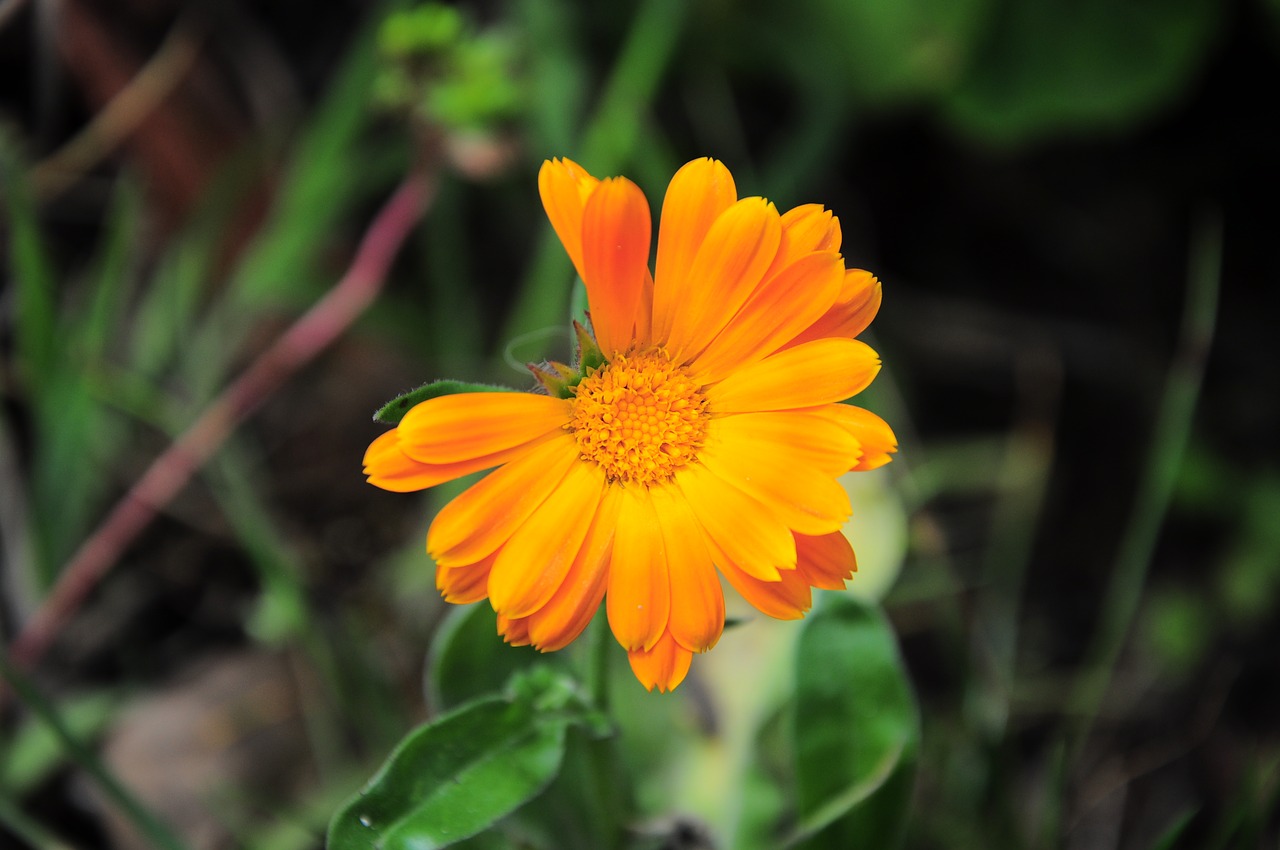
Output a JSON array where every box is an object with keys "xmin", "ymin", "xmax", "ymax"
[{"xmin": 0, "ymin": 0, "xmax": 1280, "ymax": 850}]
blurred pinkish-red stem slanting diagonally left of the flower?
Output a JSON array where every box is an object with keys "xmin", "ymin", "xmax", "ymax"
[{"xmin": 9, "ymin": 166, "xmax": 435, "ymax": 670}]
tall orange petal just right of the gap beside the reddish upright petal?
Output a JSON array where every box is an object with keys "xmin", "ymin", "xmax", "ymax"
[{"xmin": 653, "ymin": 159, "xmax": 737, "ymax": 343}]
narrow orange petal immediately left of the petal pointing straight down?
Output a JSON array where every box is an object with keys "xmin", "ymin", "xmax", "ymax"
[{"xmin": 519, "ymin": 486, "xmax": 621, "ymax": 652}]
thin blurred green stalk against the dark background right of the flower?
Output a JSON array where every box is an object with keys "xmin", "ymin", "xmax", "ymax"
[{"xmin": 1069, "ymin": 216, "xmax": 1222, "ymax": 760}]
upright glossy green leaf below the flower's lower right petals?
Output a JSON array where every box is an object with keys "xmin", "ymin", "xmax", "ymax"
[{"xmin": 788, "ymin": 595, "xmax": 920, "ymax": 850}]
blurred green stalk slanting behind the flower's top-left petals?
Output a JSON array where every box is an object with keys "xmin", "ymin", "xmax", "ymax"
[{"xmin": 502, "ymin": 0, "xmax": 687, "ymax": 350}]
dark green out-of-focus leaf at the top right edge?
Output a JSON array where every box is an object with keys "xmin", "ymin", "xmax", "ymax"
[{"xmin": 947, "ymin": 0, "xmax": 1222, "ymax": 143}]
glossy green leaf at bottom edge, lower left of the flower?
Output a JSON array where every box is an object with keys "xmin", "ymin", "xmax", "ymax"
[{"xmin": 328, "ymin": 670, "xmax": 598, "ymax": 850}]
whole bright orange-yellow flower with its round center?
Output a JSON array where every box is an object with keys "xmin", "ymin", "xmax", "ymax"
[{"xmin": 365, "ymin": 159, "xmax": 896, "ymax": 691}]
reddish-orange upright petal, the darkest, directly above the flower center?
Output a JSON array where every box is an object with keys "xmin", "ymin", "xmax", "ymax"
[{"xmin": 582, "ymin": 177, "xmax": 653, "ymax": 360}]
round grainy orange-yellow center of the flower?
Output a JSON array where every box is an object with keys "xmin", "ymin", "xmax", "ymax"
[{"xmin": 568, "ymin": 349, "xmax": 708, "ymax": 486}]
